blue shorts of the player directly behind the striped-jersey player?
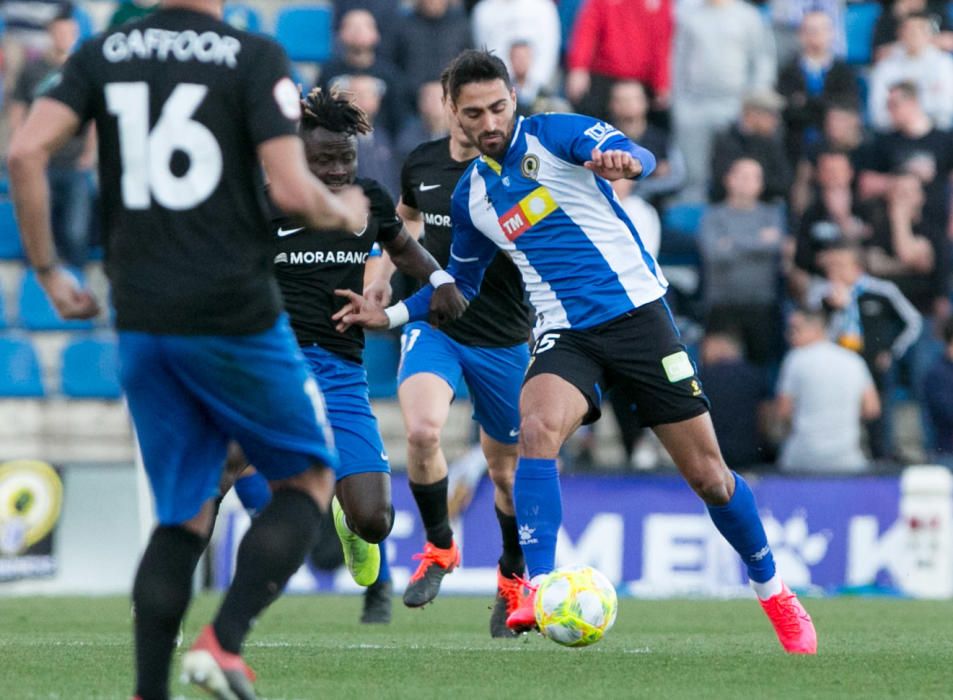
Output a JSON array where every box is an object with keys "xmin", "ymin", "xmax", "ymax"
[{"xmin": 397, "ymin": 321, "xmax": 529, "ymax": 445}]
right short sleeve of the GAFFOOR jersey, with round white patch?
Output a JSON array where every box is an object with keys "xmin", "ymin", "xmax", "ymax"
[{"xmin": 244, "ymin": 40, "xmax": 301, "ymax": 146}]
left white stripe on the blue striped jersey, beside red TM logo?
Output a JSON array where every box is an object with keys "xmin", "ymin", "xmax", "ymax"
[{"xmin": 464, "ymin": 167, "xmax": 571, "ymax": 337}]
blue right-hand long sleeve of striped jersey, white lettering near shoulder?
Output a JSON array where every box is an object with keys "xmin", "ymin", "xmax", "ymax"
[{"xmin": 533, "ymin": 114, "xmax": 655, "ymax": 179}]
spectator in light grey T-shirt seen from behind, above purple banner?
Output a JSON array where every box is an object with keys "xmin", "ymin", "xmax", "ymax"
[{"xmin": 775, "ymin": 309, "xmax": 880, "ymax": 474}]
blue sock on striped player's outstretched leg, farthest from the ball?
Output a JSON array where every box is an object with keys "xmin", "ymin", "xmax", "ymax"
[{"xmin": 708, "ymin": 472, "xmax": 775, "ymax": 583}]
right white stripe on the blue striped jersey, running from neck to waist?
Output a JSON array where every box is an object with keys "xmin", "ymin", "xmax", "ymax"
[{"xmin": 525, "ymin": 134, "xmax": 668, "ymax": 307}]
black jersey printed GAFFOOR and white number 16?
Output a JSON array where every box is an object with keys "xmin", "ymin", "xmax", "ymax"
[{"xmin": 47, "ymin": 9, "xmax": 300, "ymax": 335}]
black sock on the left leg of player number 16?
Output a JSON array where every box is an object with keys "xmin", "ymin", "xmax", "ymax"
[{"xmin": 132, "ymin": 527, "xmax": 206, "ymax": 700}]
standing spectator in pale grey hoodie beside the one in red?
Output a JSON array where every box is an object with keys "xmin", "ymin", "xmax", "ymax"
[{"xmin": 668, "ymin": 0, "xmax": 780, "ymax": 201}]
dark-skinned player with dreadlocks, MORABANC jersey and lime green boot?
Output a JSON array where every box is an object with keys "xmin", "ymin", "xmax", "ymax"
[{"xmin": 230, "ymin": 89, "xmax": 466, "ymax": 622}]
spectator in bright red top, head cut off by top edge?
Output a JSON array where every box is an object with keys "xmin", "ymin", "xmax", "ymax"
[{"xmin": 566, "ymin": 0, "xmax": 675, "ymax": 119}]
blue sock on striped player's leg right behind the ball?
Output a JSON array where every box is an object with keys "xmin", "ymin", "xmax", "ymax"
[{"xmin": 513, "ymin": 457, "xmax": 563, "ymax": 578}]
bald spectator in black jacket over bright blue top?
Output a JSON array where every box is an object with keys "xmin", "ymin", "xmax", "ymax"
[{"xmin": 778, "ymin": 10, "xmax": 860, "ymax": 163}]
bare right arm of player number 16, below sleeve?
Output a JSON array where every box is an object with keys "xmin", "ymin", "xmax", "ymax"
[{"xmin": 258, "ymin": 136, "xmax": 368, "ymax": 231}]
